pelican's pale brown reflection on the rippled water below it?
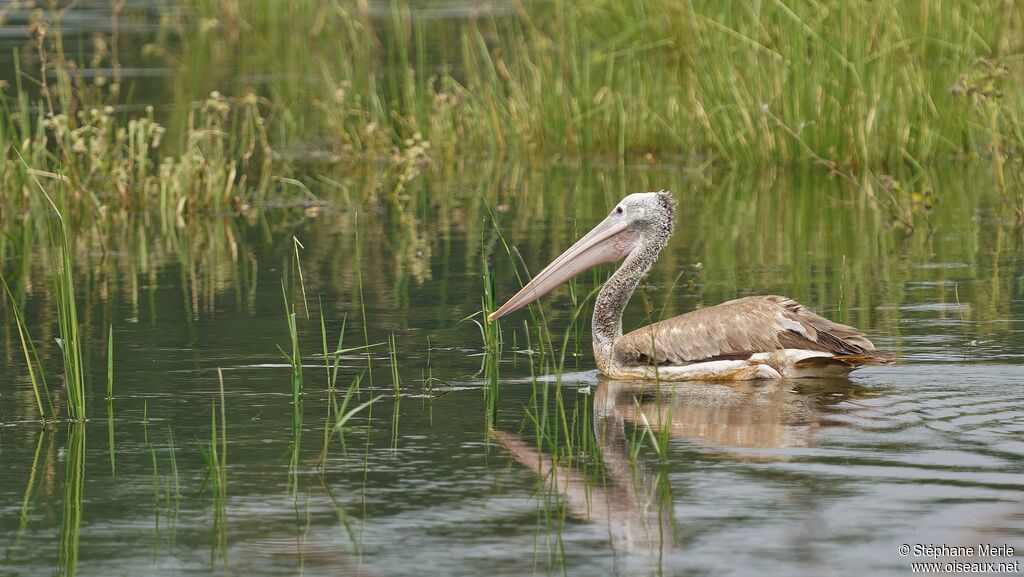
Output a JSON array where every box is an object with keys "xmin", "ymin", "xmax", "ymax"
[{"xmin": 493, "ymin": 378, "xmax": 856, "ymax": 563}]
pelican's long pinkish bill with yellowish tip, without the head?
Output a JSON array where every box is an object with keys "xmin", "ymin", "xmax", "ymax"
[{"xmin": 487, "ymin": 216, "xmax": 640, "ymax": 321}]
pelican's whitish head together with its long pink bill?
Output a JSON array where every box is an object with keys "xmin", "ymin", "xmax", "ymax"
[{"xmin": 487, "ymin": 191, "xmax": 676, "ymax": 321}]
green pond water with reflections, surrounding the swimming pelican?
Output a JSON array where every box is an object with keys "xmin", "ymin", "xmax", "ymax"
[{"xmin": 0, "ymin": 2, "xmax": 1024, "ymax": 576}]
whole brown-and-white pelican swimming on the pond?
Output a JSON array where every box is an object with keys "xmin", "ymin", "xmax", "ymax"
[{"xmin": 487, "ymin": 191, "xmax": 894, "ymax": 381}]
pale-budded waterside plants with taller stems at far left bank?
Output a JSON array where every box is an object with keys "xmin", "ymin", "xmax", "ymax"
[{"xmin": 0, "ymin": 16, "xmax": 271, "ymax": 215}]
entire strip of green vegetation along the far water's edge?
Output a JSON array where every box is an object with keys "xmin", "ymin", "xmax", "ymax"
[{"xmin": 0, "ymin": 0, "xmax": 1024, "ymax": 214}]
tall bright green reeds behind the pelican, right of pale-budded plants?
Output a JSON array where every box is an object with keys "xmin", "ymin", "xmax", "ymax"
[{"xmin": 180, "ymin": 0, "xmax": 1024, "ymax": 174}]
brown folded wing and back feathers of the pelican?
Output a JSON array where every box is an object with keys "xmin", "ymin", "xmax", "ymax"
[{"xmin": 614, "ymin": 296, "xmax": 876, "ymax": 365}]
